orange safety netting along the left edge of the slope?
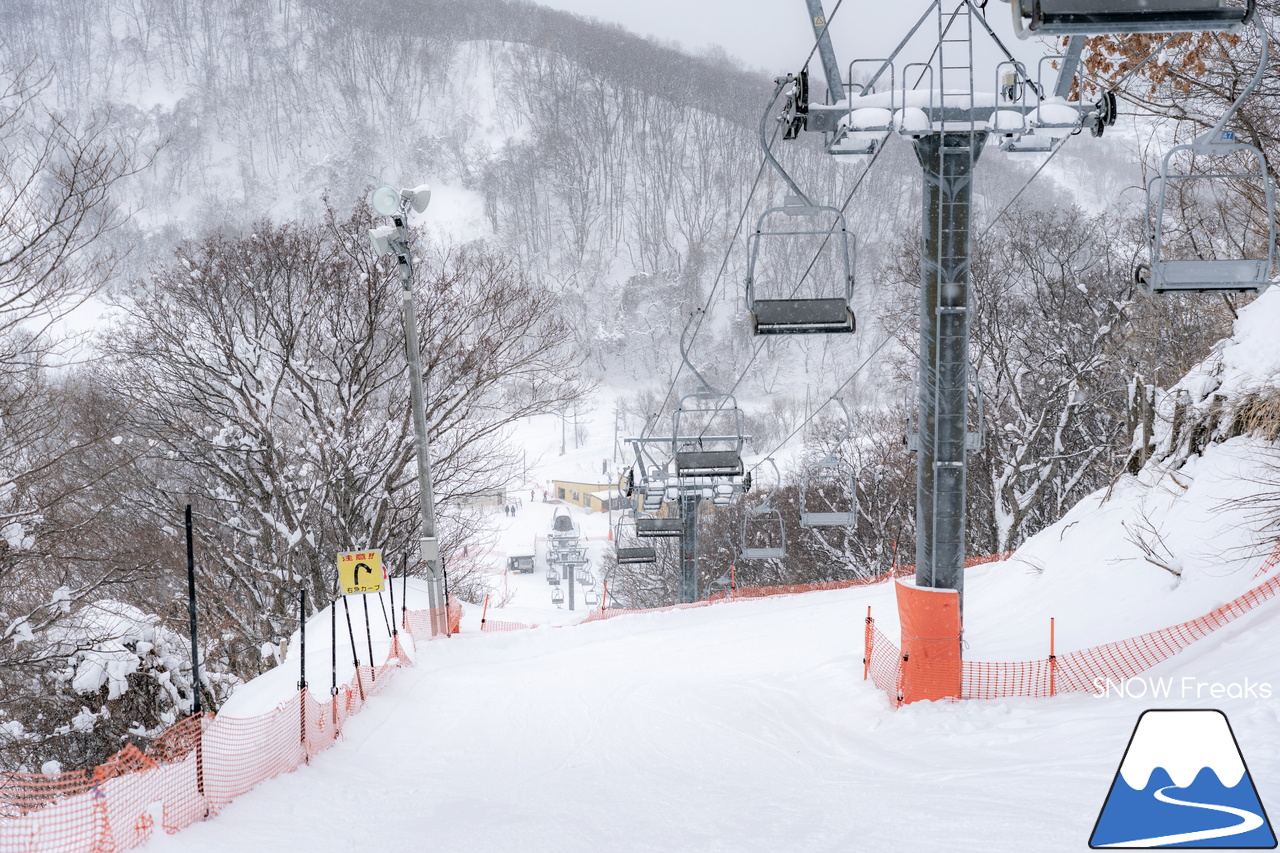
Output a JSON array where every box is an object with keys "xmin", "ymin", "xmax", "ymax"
[{"xmin": 0, "ymin": 605, "xmax": 440, "ymax": 853}]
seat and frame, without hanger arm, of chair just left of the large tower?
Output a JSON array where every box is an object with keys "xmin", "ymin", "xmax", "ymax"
[{"xmin": 746, "ymin": 197, "xmax": 856, "ymax": 334}]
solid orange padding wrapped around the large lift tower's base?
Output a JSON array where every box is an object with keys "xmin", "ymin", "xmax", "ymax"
[{"xmin": 896, "ymin": 580, "xmax": 961, "ymax": 703}]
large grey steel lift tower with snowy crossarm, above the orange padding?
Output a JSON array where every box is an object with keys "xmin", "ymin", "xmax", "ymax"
[{"xmin": 773, "ymin": 0, "xmax": 1253, "ymax": 617}]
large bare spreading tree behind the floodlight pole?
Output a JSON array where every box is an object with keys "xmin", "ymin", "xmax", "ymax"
[{"xmin": 103, "ymin": 206, "xmax": 586, "ymax": 674}]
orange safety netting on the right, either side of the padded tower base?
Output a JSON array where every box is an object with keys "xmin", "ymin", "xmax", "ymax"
[{"xmin": 864, "ymin": 546, "xmax": 1280, "ymax": 704}]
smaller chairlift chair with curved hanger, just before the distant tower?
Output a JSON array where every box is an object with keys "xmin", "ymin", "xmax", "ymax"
[{"xmin": 671, "ymin": 310, "xmax": 746, "ymax": 478}]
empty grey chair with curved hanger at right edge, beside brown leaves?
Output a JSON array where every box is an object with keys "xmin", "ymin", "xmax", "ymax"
[{"xmin": 1134, "ymin": 17, "xmax": 1276, "ymax": 295}]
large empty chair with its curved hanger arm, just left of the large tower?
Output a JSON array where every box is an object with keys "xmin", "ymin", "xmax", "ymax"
[{"xmin": 746, "ymin": 74, "xmax": 856, "ymax": 334}]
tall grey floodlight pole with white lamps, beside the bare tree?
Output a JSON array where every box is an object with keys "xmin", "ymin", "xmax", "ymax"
[{"xmin": 388, "ymin": 200, "xmax": 449, "ymax": 637}]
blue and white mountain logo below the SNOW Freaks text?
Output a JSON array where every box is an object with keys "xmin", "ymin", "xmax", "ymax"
[{"xmin": 1089, "ymin": 710, "xmax": 1276, "ymax": 850}]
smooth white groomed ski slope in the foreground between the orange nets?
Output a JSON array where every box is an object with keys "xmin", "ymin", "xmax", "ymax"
[{"xmin": 140, "ymin": 563, "xmax": 1280, "ymax": 853}]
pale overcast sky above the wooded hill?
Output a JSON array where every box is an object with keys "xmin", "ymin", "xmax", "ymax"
[{"xmin": 527, "ymin": 0, "xmax": 1046, "ymax": 91}]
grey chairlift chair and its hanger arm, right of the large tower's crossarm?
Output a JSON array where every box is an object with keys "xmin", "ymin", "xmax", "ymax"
[{"xmin": 1134, "ymin": 20, "xmax": 1276, "ymax": 296}]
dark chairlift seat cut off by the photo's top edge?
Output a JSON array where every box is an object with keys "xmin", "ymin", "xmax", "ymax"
[{"xmin": 1005, "ymin": 0, "xmax": 1256, "ymax": 38}]
